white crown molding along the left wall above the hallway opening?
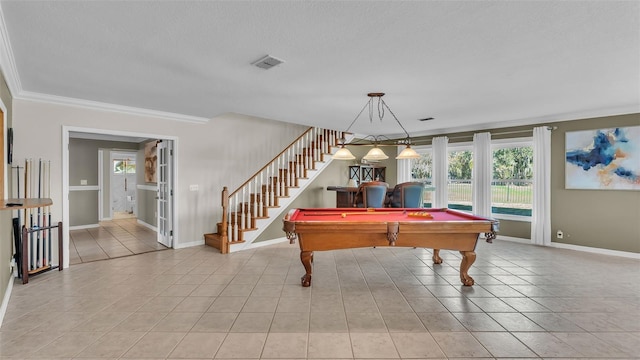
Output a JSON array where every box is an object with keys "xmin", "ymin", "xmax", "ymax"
[{"xmin": 14, "ymin": 91, "xmax": 210, "ymax": 124}]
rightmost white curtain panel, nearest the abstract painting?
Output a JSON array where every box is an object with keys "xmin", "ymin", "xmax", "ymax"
[{"xmin": 531, "ymin": 126, "xmax": 551, "ymax": 246}]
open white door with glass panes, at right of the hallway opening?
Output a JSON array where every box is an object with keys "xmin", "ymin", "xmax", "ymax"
[{"xmin": 156, "ymin": 140, "xmax": 173, "ymax": 247}]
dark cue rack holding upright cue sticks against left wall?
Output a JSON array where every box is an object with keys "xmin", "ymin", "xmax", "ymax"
[{"xmin": 0, "ymin": 159, "xmax": 63, "ymax": 284}]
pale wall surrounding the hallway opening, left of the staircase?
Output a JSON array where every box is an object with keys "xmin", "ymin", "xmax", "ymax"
[{"xmin": 13, "ymin": 100, "xmax": 307, "ymax": 258}]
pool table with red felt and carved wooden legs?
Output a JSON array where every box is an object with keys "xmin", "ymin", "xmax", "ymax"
[{"xmin": 283, "ymin": 208, "xmax": 498, "ymax": 286}]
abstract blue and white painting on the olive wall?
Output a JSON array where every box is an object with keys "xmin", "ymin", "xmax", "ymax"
[{"xmin": 565, "ymin": 126, "xmax": 640, "ymax": 190}]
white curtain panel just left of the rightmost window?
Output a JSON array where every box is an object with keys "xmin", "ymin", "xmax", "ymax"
[{"xmin": 472, "ymin": 132, "xmax": 493, "ymax": 217}]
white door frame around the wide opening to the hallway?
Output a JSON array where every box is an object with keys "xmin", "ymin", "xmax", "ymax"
[{"xmin": 62, "ymin": 125, "xmax": 180, "ymax": 267}]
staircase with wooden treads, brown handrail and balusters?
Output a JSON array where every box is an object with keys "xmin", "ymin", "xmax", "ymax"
[{"xmin": 204, "ymin": 127, "xmax": 347, "ymax": 254}]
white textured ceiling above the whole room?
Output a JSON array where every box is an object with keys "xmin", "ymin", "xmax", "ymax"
[{"xmin": 0, "ymin": 1, "xmax": 640, "ymax": 136}]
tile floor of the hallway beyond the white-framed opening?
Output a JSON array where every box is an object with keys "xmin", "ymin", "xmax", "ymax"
[{"xmin": 69, "ymin": 218, "xmax": 167, "ymax": 265}]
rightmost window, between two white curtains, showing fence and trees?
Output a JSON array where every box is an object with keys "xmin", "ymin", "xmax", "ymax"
[{"xmin": 491, "ymin": 138, "xmax": 533, "ymax": 216}]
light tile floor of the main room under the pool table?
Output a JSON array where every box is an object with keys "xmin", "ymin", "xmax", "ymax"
[{"xmin": 0, "ymin": 240, "xmax": 640, "ymax": 359}]
